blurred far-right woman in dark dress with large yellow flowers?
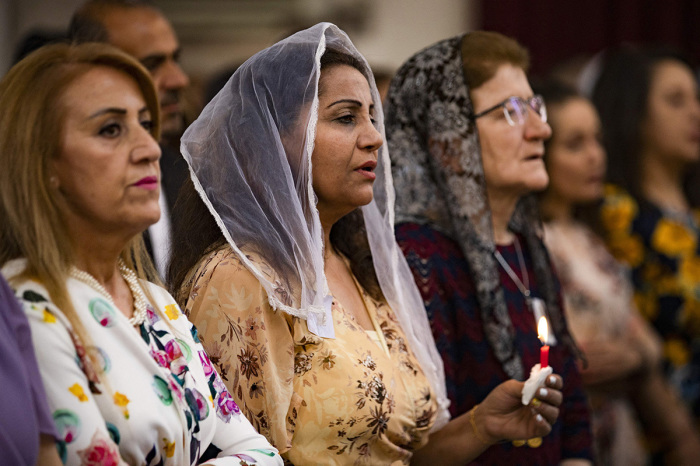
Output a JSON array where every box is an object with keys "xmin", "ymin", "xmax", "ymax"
[{"xmin": 593, "ymin": 48, "xmax": 700, "ymax": 421}]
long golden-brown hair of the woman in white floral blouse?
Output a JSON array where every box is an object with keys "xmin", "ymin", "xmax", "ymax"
[{"xmin": 0, "ymin": 43, "xmax": 160, "ymax": 374}]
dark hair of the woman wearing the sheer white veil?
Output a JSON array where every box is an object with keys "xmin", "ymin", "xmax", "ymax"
[{"xmin": 167, "ymin": 48, "xmax": 382, "ymax": 304}]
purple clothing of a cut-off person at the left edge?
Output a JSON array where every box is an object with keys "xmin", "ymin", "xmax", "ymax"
[{"xmin": 0, "ymin": 275, "xmax": 56, "ymax": 465}]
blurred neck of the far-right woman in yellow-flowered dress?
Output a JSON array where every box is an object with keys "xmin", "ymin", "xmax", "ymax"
[{"xmin": 640, "ymin": 154, "xmax": 689, "ymax": 211}]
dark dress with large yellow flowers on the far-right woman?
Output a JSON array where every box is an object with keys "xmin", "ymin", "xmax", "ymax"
[{"xmin": 601, "ymin": 186, "xmax": 700, "ymax": 420}]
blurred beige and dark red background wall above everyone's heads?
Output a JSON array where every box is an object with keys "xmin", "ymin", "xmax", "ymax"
[{"xmin": 0, "ymin": 0, "xmax": 700, "ymax": 107}]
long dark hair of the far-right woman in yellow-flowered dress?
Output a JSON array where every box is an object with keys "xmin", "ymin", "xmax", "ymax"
[{"xmin": 591, "ymin": 45, "xmax": 693, "ymax": 199}]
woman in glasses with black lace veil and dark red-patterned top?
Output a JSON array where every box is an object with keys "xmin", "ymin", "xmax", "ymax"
[{"xmin": 386, "ymin": 32, "xmax": 591, "ymax": 465}]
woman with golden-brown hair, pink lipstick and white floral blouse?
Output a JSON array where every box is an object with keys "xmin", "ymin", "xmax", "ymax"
[{"xmin": 0, "ymin": 44, "xmax": 282, "ymax": 465}]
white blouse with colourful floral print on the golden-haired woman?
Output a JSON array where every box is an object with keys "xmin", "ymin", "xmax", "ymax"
[{"xmin": 3, "ymin": 260, "xmax": 282, "ymax": 466}]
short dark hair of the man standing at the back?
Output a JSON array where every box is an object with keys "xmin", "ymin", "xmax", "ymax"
[{"xmin": 68, "ymin": 0, "xmax": 158, "ymax": 44}]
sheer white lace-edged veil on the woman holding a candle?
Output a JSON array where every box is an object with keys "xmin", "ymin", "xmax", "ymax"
[{"xmin": 181, "ymin": 23, "xmax": 449, "ymax": 428}]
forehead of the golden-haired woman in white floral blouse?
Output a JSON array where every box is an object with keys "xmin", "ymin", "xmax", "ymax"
[{"xmin": 61, "ymin": 66, "xmax": 145, "ymax": 119}]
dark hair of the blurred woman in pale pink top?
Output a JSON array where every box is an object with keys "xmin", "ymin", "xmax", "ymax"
[{"xmin": 532, "ymin": 79, "xmax": 603, "ymax": 235}]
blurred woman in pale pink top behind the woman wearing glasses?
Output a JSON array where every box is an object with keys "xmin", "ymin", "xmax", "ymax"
[{"xmin": 535, "ymin": 82, "xmax": 700, "ymax": 465}]
